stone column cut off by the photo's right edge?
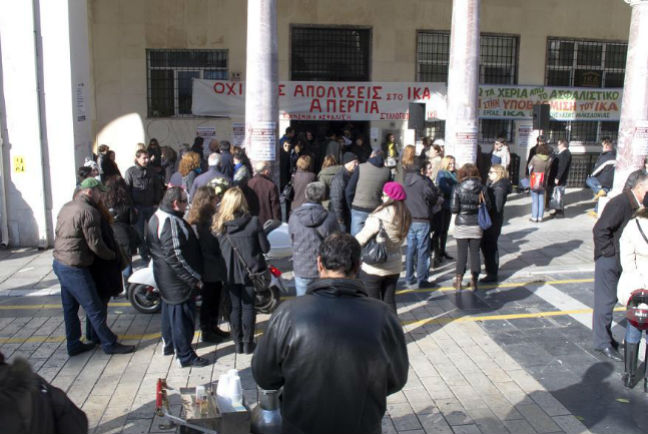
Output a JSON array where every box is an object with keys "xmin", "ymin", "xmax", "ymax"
[{"xmin": 613, "ymin": 0, "xmax": 648, "ymax": 193}]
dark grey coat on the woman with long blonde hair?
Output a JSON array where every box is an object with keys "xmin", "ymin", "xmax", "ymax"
[{"xmin": 218, "ymin": 214, "xmax": 270, "ymax": 286}]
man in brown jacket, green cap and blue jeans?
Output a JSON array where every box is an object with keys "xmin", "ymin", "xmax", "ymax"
[{"xmin": 53, "ymin": 178, "xmax": 135, "ymax": 356}]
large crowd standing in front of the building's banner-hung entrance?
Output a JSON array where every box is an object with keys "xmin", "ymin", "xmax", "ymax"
[{"xmin": 59, "ymin": 128, "xmax": 528, "ymax": 366}]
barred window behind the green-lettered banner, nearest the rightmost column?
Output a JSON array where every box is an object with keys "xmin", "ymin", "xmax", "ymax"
[{"xmin": 545, "ymin": 38, "xmax": 628, "ymax": 143}]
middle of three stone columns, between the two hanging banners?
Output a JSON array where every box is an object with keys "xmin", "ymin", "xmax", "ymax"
[{"xmin": 445, "ymin": 0, "xmax": 480, "ymax": 167}]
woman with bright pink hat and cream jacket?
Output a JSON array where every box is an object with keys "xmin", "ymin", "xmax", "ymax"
[{"xmin": 355, "ymin": 182, "xmax": 412, "ymax": 312}]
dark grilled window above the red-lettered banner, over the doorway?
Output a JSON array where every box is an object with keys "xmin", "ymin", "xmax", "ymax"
[{"xmin": 290, "ymin": 25, "xmax": 371, "ymax": 81}]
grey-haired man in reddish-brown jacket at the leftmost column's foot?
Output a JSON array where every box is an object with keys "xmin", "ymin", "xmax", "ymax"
[{"xmin": 247, "ymin": 161, "xmax": 281, "ymax": 225}]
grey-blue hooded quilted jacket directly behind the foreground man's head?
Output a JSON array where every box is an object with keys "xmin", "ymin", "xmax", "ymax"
[{"xmin": 288, "ymin": 202, "xmax": 340, "ymax": 278}]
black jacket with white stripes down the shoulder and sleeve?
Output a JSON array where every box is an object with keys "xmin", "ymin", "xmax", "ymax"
[{"xmin": 147, "ymin": 207, "xmax": 203, "ymax": 304}]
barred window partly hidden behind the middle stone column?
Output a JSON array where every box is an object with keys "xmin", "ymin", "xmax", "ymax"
[{"xmin": 416, "ymin": 31, "xmax": 519, "ymax": 143}]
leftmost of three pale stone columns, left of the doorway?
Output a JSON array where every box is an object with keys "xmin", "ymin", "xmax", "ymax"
[{"xmin": 245, "ymin": 0, "xmax": 279, "ymax": 182}]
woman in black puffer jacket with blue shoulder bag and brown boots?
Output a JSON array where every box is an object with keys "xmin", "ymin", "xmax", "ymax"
[{"xmin": 450, "ymin": 163, "xmax": 490, "ymax": 291}]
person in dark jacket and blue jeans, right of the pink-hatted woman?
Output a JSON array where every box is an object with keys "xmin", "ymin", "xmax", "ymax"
[{"xmin": 403, "ymin": 157, "xmax": 438, "ymax": 288}]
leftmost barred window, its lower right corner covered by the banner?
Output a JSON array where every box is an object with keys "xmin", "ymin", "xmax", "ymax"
[{"xmin": 146, "ymin": 50, "xmax": 228, "ymax": 118}]
